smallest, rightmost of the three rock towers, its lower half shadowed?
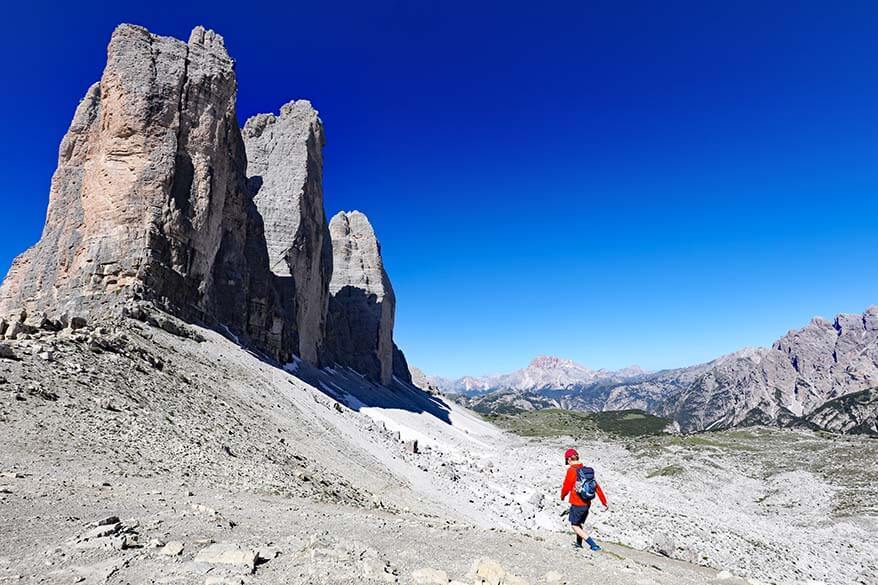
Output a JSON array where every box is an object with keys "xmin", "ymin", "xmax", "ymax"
[{"xmin": 325, "ymin": 211, "xmax": 398, "ymax": 384}]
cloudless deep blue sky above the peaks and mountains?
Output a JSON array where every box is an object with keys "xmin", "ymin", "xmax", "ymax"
[{"xmin": 0, "ymin": 0, "xmax": 878, "ymax": 375}]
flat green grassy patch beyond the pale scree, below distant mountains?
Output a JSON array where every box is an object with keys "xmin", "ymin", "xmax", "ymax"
[{"xmin": 484, "ymin": 408, "xmax": 670, "ymax": 437}]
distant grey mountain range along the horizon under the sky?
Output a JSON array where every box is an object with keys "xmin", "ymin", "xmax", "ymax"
[{"xmin": 431, "ymin": 306, "xmax": 878, "ymax": 435}]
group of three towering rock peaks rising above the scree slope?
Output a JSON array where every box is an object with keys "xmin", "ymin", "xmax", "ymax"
[{"xmin": 0, "ymin": 25, "xmax": 409, "ymax": 383}]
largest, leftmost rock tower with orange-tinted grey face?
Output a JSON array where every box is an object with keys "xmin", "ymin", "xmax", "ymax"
[{"xmin": 0, "ymin": 25, "xmax": 282, "ymax": 354}]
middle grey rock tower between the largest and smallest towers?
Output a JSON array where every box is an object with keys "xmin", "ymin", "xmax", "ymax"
[{"xmin": 242, "ymin": 100, "xmax": 332, "ymax": 365}]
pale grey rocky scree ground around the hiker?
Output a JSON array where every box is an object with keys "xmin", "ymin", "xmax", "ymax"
[{"xmin": 0, "ymin": 310, "xmax": 878, "ymax": 585}]
